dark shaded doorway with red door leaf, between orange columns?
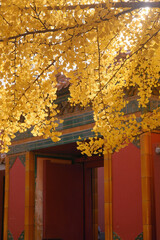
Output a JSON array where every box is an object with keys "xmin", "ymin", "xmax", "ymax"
[{"xmin": 37, "ymin": 143, "xmax": 104, "ymax": 240}]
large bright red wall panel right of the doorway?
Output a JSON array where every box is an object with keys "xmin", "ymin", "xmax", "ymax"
[{"xmin": 112, "ymin": 144, "xmax": 143, "ymax": 240}]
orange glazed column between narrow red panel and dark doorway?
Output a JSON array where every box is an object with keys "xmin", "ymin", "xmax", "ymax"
[{"xmin": 24, "ymin": 152, "xmax": 35, "ymax": 240}]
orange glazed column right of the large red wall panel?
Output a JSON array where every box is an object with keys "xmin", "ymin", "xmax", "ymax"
[{"xmin": 140, "ymin": 133, "xmax": 154, "ymax": 240}]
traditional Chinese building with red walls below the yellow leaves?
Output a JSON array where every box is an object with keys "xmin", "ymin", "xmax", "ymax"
[{"xmin": 0, "ymin": 77, "xmax": 160, "ymax": 240}]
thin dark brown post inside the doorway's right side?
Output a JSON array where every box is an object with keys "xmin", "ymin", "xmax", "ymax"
[{"xmin": 92, "ymin": 168, "xmax": 98, "ymax": 240}]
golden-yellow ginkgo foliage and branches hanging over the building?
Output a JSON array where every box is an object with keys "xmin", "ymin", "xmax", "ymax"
[{"xmin": 0, "ymin": 0, "xmax": 160, "ymax": 156}]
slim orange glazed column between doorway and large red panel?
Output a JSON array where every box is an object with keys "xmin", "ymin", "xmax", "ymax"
[{"xmin": 104, "ymin": 153, "xmax": 113, "ymax": 240}]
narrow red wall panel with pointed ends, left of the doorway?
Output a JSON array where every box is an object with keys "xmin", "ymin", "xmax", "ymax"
[{"xmin": 8, "ymin": 157, "xmax": 25, "ymax": 240}]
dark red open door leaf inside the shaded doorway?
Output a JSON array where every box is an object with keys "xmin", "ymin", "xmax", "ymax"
[{"xmin": 43, "ymin": 161, "xmax": 84, "ymax": 240}]
